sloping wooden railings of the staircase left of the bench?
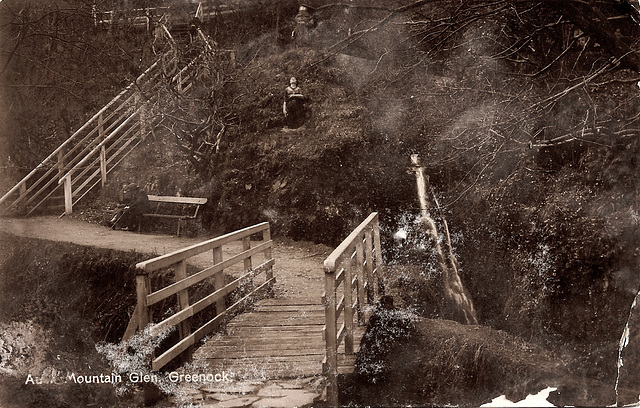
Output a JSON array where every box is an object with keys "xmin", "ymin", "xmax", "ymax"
[{"xmin": 0, "ymin": 26, "xmax": 213, "ymax": 215}]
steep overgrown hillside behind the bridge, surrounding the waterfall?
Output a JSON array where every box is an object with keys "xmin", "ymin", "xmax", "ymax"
[{"xmin": 2, "ymin": 0, "xmax": 640, "ymax": 404}]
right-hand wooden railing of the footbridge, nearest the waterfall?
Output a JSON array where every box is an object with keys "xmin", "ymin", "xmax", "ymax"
[{"xmin": 322, "ymin": 212, "xmax": 384, "ymax": 406}]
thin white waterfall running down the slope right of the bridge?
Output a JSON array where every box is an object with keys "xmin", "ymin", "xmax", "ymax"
[{"xmin": 411, "ymin": 154, "xmax": 478, "ymax": 324}]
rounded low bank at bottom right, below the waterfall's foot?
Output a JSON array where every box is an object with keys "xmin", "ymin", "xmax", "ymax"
[{"xmin": 350, "ymin": 311, "xmax": 637, "ymax": 407}]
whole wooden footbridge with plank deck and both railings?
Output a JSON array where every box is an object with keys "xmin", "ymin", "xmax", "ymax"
[{"xmin": 125, "ymin": 213, "xmax": 382, "ymax": 406}]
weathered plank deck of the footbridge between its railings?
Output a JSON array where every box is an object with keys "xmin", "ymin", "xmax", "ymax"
[{"xmin": 194, "ymin": 298, "xmax": 364, "ymax": 380}]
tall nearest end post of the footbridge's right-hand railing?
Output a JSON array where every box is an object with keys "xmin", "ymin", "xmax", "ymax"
[{"xmin": 324, "ymin": 269, "xmax": 338, "ymax": 407}]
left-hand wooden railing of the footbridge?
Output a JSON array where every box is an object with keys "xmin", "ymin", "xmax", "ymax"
[{"xmin": 123, "ymin": 222, "xmax": 275, "ymax": 370}]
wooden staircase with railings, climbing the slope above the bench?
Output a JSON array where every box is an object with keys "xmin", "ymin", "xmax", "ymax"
[{"xmin": 0, "ymin": 32, "xmax": 212, "ymax": 215}]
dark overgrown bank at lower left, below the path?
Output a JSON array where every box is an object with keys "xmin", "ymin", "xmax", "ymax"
[{"xmin": 0, "ymin": 235, "xmax": 144, "ymax": 407}]
